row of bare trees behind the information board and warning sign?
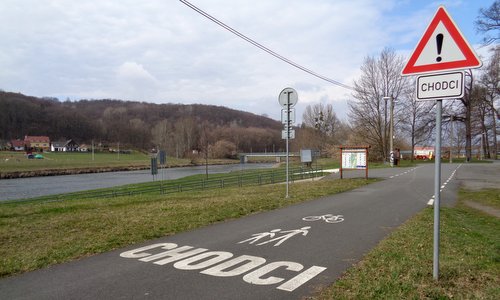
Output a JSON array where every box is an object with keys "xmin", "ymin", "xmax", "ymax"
[{"xmin": 297, "ymin": 0, "xmax": 500, "ymax": 161}]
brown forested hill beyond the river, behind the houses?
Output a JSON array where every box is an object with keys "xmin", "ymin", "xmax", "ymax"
[{"xmin": 0, "ymin": 91, "xmax": 281, "ymax": 153}]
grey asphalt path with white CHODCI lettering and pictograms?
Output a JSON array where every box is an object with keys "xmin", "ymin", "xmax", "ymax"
[{"xmin": 0, "ymin": 164, "xmax": 468, "ymax": 299}]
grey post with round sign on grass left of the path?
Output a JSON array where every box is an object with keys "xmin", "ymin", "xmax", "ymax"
[{"xmin": 278, "ymin": 88, "xmax": 299, "ymax": 198}]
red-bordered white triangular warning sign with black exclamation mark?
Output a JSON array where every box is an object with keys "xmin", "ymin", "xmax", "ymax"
[{"xmin": 401, "ymin": 6, "xmax": 482, "ymax": 75}]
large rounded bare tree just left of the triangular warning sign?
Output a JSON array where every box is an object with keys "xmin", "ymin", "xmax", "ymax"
[{"xmin": 348, "ymin": 49, "xmax": 408, "ymax": 160}]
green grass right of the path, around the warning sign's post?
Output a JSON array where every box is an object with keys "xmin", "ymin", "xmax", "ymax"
[{"xmin": 317, "ymin": 189, "xmax": 500, "ymax": 299}]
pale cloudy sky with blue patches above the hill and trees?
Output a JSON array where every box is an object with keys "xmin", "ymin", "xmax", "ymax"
[{"xmin": 0, "ymin": 0, "xmax": 493, "ymax": 122}]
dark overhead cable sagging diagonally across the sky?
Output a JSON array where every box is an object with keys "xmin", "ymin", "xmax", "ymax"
[{"xmin": 179, "ymin": 0, "xmax": 354, "ymax": 90}]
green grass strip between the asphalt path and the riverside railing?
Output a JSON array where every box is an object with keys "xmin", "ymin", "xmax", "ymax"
[{"xmin": 0, "ymin": 179, "xmax": 374, "ymax": 277}]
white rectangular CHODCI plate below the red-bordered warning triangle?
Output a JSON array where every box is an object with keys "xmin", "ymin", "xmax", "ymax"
[{"xmin": 417, "ymin": 72, "xmax": 464, "ymax": 101}]
